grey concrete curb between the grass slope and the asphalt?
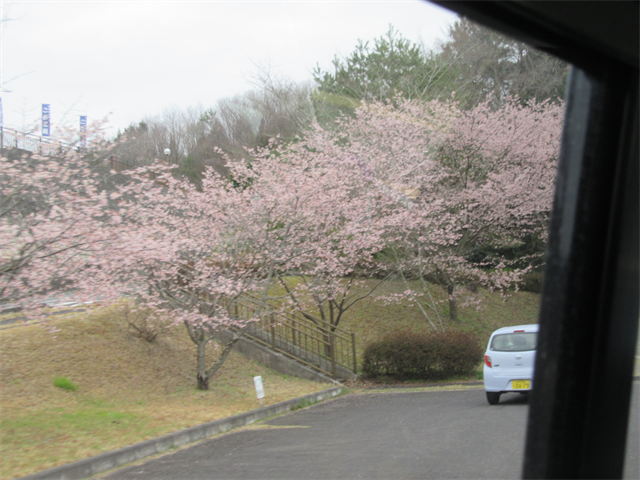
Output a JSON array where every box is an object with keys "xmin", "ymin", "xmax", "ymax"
[{"xmin": 19, "ymin": 387, "xmax": 343, "ymax": 480}]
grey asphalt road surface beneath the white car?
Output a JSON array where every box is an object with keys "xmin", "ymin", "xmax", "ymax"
[{"xmin": 101, "ymin": 383, "xmax": 640, "ymax": 480}]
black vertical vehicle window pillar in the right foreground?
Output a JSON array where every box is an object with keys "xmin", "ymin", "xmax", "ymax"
[{"xmin": 523, "ymin": 67, "xmax": 640, "ymax": 480}]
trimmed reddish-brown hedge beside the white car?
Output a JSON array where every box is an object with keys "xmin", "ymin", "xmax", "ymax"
[{"xmin": 362, "ymin": 330, "xmax": 483, "ymax": 380}]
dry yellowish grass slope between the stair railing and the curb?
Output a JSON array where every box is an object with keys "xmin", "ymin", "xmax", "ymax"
[{"xmin": 0, "ymin": 309, "xmax": 329, "ymax": 479}]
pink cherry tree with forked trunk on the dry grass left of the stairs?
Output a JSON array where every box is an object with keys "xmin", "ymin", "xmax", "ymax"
[{"xmin": 95, "ymin": 166, "xmax": 273, "ymax": 390}]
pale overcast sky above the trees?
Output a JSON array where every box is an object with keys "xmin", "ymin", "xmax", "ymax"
[{"xmin": 0, "ymin": 0, "xmax": 455, "ymax": 135}]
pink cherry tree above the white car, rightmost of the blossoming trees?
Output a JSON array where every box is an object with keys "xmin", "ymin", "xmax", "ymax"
[{"xmin": 419, "ymin": 98, "xmax": 563, "ymax": 320}]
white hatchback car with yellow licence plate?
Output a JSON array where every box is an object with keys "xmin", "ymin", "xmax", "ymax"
[{"xmin": 483, "ymin": 325, "xmax": 538, "ymax": 405}]
